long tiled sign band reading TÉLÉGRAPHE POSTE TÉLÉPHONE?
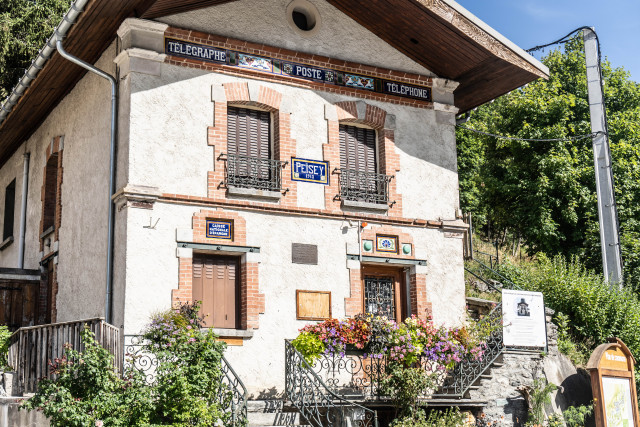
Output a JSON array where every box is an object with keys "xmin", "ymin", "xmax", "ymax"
[{"xmin": 165, "ymin": 38, "xmax": 431, "ymax": 101}]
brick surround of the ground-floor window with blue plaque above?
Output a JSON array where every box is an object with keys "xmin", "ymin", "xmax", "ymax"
[{"xmin": 171, "ymin": 210, "xmax": 265, "ymax": 329}]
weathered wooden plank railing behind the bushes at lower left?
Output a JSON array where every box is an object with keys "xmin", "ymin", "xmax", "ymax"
[{"xmin": 8, "ymin": 318, "xmax": 123, "ymax": 393}]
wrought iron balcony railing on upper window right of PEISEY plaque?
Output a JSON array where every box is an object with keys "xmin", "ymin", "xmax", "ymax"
[{"xmin": 334, "ymin": 169, "xmax": 393, "ymax": 204}]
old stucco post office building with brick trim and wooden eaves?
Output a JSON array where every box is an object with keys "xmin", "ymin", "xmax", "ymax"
[{"xmin": 0, "ymin": 0, "xmax": 548, "ymax": 397}]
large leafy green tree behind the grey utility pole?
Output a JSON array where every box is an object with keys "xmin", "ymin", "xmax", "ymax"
[{"xmin": 457, "ymin": 37, "xmax": 640, "ymax": 286}]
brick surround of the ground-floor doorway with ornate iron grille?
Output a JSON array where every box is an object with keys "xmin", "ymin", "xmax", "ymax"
[{"xmin": 344, "ymin": 225, "xmax": 432, "ymax": 319}]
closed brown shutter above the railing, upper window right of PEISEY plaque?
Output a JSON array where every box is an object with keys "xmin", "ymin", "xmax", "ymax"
[{"xmin": 340, "ymin": 125, "xmax": 378, "ymax": 173}]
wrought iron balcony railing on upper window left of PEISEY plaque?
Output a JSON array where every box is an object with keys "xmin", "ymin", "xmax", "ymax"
[{"xmin": 222, "ymin": 153, "xmax": 287, "ymax": 191}]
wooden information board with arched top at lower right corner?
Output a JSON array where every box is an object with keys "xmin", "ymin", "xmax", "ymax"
[{"xmin": 587, "ymin": 338, "xmax": 640, "ymax": 427}]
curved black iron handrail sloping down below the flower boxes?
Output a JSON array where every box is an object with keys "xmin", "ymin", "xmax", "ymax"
[{"xmin": 285, "ymin": 340, "xmax": 378, "ymax": 427}]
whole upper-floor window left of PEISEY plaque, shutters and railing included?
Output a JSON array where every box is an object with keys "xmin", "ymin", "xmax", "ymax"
[{"xmin": 226, "ymin": 107, "xmax": 283, "ymax": 191}]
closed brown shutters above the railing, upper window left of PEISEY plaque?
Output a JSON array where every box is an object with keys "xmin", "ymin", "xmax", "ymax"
[{"xmin": 227, "ymin": 107, "xmax": 271, "ymax": 159}]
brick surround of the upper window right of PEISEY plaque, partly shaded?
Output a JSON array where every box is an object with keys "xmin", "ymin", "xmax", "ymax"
[{"xmin": 322, "ymin": 101, "xmax": 402, "ymax": 217}]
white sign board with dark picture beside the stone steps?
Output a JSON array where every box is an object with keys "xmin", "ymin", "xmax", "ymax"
[{"xmin": 502, "ymin": 289, "xmax": 547, "ymax": 348}]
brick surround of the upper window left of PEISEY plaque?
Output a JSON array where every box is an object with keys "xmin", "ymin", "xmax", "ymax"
[{"xmin": 207, "ymin": 82, "xmax": 298, "ymax": 207}]
